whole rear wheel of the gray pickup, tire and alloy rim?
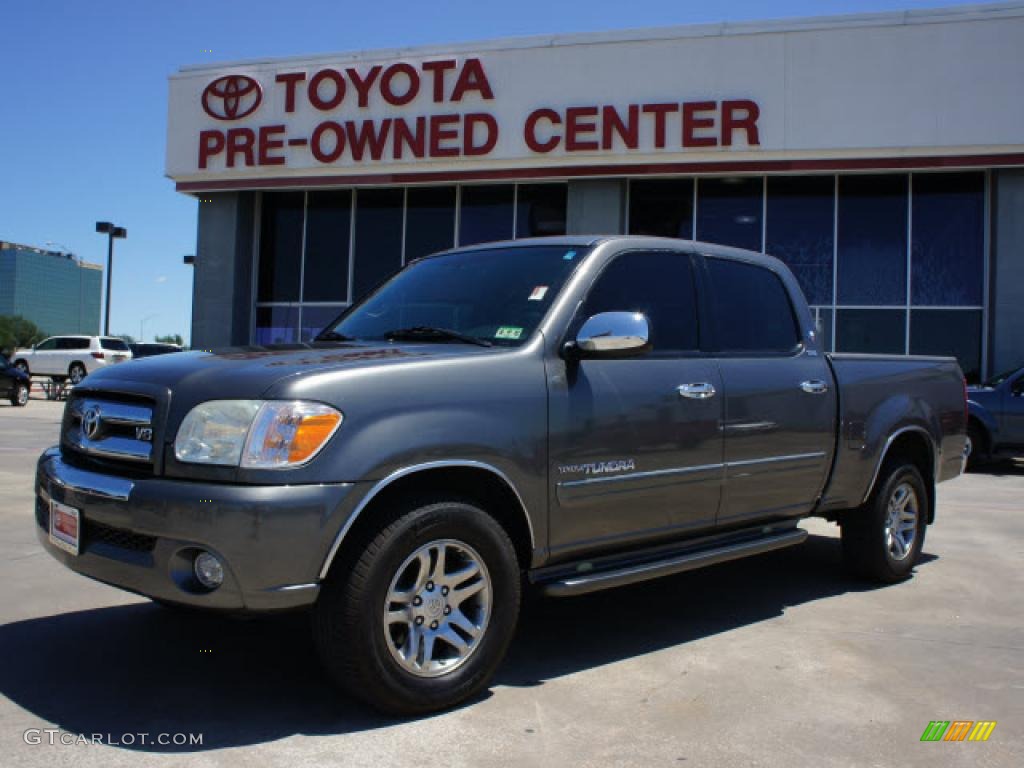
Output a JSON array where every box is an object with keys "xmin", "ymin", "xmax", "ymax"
[{"xmin": 843, "ymin": 463, "xmax": 929, "ymax": 584}]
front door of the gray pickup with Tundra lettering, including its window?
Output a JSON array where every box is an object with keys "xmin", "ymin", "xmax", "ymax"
[{"xmin": 549, "ymin": 251, "xmax": 724, "ymax": 559}]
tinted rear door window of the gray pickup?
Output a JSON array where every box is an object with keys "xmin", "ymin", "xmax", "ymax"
[{"xmin": 708, "ymin": 257, "xmax": 800, "ymax": 354}]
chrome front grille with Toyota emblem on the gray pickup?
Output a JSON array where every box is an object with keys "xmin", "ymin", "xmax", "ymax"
[{"xmin": 60, "ymin": 392, "xmax": 155, "ymax": 474}]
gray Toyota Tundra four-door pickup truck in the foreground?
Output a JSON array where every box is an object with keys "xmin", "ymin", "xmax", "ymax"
[{"xmin": 36, "ymin": 237, "xmax": 967, "ymax": 714}]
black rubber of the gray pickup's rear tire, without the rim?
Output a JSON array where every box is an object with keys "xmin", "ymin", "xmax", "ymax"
[{"xmin": 842, "ymin": 462, "xmax": 931, "ymax": 584}]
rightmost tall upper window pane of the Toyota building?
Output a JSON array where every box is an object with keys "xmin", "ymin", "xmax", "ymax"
[{"xmin": 910, "ymin": 172, "xmax": 985, "ymax": 307}]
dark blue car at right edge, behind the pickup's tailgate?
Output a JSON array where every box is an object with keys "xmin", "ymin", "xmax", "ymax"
[{"xmin": 968, "ymin": 366, "xmax": 1024, "ymax": 467}]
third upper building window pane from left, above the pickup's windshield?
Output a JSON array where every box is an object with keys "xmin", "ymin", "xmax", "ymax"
[{"xmin": 352, "ymin": 188, "xmax": 406, "ymax": 301}]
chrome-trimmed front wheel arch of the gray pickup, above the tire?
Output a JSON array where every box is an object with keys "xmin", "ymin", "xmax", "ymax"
[{"xmin": 318, "ymin": 460, "xmax": 537, "ymax": 581}]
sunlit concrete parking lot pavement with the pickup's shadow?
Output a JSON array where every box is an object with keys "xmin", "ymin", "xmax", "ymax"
[{"xmin": 0, "ymin": 399, "xmax": 1024, "ymax": 768}]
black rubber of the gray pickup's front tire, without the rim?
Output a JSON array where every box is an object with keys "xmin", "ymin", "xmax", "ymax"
[{"xmin": 312, "ymin": 499, "xmax": 520, "ymax": 716}]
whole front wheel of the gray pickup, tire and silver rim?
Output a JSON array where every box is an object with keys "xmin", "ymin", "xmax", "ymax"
[{"xmin": 313, "ymin": 502, "xmax": 520, "ymax": 715}]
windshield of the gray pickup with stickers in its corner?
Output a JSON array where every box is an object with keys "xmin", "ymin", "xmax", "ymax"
[{"xmin": 322, "ymin": 246, "xmax": 586, "ymax": 346}]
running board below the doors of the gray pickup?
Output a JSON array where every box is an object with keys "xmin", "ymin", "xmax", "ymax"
[{"xmin": 543, "ymin": 528, "xmax": 807, "ymax": 597}]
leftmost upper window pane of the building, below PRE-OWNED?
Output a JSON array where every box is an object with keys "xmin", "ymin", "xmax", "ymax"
[{"xmin": 256, "ymin": 191, "xmax": 305, "ymax": 301}]
